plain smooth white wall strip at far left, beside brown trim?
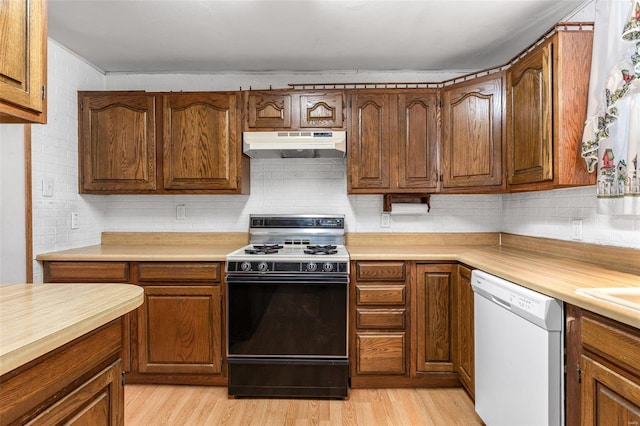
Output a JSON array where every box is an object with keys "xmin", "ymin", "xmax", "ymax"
[{"xmin": 0, "ymin": 124, "xmax": 27, "ymax": 284}]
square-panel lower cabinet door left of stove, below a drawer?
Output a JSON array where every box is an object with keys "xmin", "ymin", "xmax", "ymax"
[{"xmin": 137, "ymin": 285, "xmax": 222, "ymax": 374}]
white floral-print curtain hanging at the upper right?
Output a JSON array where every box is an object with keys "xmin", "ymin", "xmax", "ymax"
[{"xmin": 582, "ymin": 0, "xmax": 640, "ymax": 215}]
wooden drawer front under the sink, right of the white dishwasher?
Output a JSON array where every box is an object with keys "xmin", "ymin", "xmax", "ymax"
[{"xmin": 582, "ymin": 314, "xmax": 640, "ymax": 373}]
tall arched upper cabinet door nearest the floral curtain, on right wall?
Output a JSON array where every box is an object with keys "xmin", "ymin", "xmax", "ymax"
[{"xmin": 507, "ymin": 44, "xmax": 553, "ymax": 184}]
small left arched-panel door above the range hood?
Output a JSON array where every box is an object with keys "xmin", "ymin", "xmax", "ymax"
[{"xmin": 247, "ymin": 92, "xmax": 292, "ymax": 129}]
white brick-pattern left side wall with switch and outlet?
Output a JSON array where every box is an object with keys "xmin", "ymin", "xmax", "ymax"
[{"xmin": 31, "ymin": 40, "xmax": 106, "ymax": 282}]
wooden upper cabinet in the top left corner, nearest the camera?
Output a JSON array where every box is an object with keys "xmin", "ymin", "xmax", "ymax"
[{"xmin": 0, "ymin": 0, "xmax": 47, "ymax": 123}]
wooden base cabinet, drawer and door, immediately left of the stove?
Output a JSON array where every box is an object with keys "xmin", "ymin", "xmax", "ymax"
[{"xmin": 134, "ymin": 262, "xmax": 223, "ymax": 381}]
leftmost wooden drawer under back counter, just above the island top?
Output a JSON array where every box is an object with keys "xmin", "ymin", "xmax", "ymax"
[{"xmin": 44, "ymin": 262, "xmax": 129, "ymax": 283}]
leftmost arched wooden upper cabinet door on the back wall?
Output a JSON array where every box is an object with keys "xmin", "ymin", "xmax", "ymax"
[{"xmin": 78, "ymin": 92, "xmax": 156, "ymax": 193}]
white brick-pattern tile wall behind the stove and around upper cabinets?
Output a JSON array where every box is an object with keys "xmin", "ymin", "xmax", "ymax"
[{"xmin": 27, "ymin": 41, "xmax": 640, "ymax": 282}]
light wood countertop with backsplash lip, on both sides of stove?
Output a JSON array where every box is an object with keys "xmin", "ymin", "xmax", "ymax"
[{"xmin": 37, "ymin": 233, "xmax": 640, "ymax": 328}]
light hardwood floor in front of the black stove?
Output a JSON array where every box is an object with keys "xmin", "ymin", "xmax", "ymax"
[{"xmin": 125, "ymin": 385, "xmax": 483, "ymax": 426}]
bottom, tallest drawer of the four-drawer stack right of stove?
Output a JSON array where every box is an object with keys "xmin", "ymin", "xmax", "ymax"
[{"xmin": 356, "ymin": 333, "xmax": 406, "ymax": 374}]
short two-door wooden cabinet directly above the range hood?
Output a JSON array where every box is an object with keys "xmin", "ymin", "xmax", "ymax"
[{"xmin": 244, "ymin": 90, "xmax": 345, "ymax": 131}]
